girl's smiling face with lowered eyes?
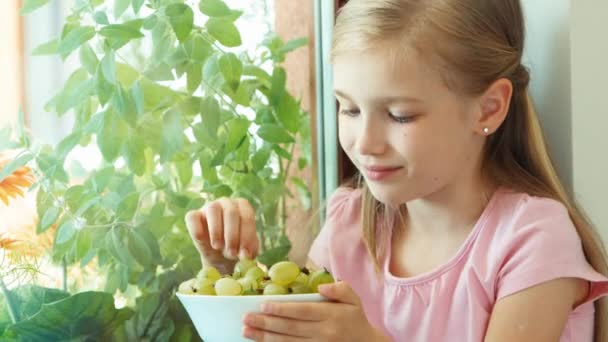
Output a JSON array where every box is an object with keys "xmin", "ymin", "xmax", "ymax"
[{"xmin": 334, "ymin": 50, "xmax": 484, "ymax": 205}]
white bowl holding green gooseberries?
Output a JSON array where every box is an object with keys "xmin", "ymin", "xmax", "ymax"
[{"xmin": 177, "ymin": 293, "xmax": 327, "ymax": 342}]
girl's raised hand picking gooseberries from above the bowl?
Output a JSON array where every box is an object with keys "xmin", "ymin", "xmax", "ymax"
[{"xmin": 185, "ymin": 198, "xmax": 259, "ymax": 274}]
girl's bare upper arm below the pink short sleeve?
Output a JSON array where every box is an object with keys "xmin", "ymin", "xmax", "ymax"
[{"xmin": 485, "ymin": 278, "xmax": 589, "ymax": 342}]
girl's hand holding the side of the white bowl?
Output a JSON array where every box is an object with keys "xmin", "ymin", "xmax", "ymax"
[{"xmin": 243, "ymin": 282, "xmax": 390, "ymax": 342}]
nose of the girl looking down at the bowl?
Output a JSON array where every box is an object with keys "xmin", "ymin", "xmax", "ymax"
[{"xmin": 355, "ymin": 114, "xmax": 387, "ymax": 155}]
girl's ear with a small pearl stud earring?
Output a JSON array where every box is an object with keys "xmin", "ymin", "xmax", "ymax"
[{"xmin": 475, "ymin": 78, "xmax": 513, "ymax": 135}]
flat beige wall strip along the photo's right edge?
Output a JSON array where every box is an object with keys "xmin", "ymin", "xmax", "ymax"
[{"xmin": 571, "ymin": 0, "xmax": 608, "ymax": 241}]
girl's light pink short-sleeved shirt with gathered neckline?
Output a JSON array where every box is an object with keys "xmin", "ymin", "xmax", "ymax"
[{"xmin": 309, "ymin": 188, "xmax": 608, "ymax": 342}]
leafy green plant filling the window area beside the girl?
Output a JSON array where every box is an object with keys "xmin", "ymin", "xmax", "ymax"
[{"xmin": 0, "ymin": 0, "xmax": 311, "ymax": 341}]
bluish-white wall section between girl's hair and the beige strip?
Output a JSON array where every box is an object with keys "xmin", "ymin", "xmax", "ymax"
[{"xmin": 522, "ymin": 0, "xmax": 572, "ymax": 188}]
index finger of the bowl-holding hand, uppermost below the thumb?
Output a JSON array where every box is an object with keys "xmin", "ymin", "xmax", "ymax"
[{"xmin": 262, "ymin": 302, "xmax": 336, "ymax": 322}]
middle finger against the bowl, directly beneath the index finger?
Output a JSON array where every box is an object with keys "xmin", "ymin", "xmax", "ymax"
[{"xmin": 244, "ymin": 314, "xmax": 319, "ymax": 341}]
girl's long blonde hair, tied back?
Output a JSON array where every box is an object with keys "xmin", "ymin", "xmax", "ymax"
[{"xmin": 332, "ymin": 0, "xmax": 608, "ymax": 342}]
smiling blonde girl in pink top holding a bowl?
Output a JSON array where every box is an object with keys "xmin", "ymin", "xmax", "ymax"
[{"xmin": 187, "ymin": 0, "xmax": 608, "ymax": 342}]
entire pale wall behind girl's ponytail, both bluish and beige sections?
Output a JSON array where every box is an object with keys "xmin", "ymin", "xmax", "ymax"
[{"xmin": 522, "ymin": 0, "xmax": 608, "ymax": 242}]
